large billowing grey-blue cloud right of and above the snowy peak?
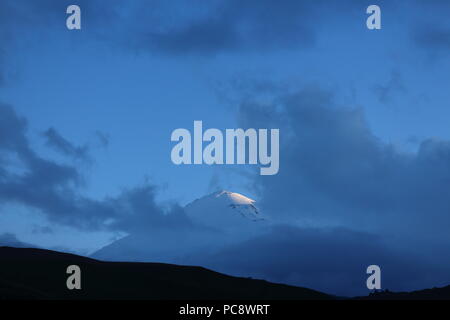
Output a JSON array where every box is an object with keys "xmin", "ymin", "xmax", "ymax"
[{"xmin": 240, "ymin": 88, "xmax": 450, "ymax": 239}]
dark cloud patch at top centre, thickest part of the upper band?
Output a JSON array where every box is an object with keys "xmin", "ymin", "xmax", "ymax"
[{"xmin": 141, "ymin": 0, "xmax": 316, "ymax": 54}]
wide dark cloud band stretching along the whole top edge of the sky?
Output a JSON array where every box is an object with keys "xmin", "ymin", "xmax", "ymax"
[{"xmin": 0, "ymin": 0, "xmax": 448, "ymax": 61}]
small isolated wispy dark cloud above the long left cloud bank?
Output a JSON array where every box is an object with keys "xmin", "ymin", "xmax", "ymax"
[{"xmin": 43, "ymin": 128, "xmax": 90, "ymax": 161}]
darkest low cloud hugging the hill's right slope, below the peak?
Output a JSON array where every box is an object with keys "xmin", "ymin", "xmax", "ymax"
[{"xmin": 192, "ymin": 226, "xmax": 450, "ymax": 296}]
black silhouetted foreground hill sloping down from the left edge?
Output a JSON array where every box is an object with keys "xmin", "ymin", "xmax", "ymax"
[{"xmin": 0, "ymin": 247, "xmax": 332, "ymax": 300}]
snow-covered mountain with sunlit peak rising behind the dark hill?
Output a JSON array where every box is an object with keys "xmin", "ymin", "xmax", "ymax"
[{"xmin": 92, "ymin": 191, "xmax": 267, "ymax": 264}]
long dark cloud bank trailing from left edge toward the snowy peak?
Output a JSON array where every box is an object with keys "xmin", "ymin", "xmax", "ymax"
[{"xmin": 0, "ymin": 105, "xmax": 189, "ymax": 232}]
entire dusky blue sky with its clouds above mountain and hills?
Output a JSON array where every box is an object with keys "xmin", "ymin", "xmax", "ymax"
[{"xmin": 0, "ymin": 0, "xmax": 450, "ymax": 296}]
